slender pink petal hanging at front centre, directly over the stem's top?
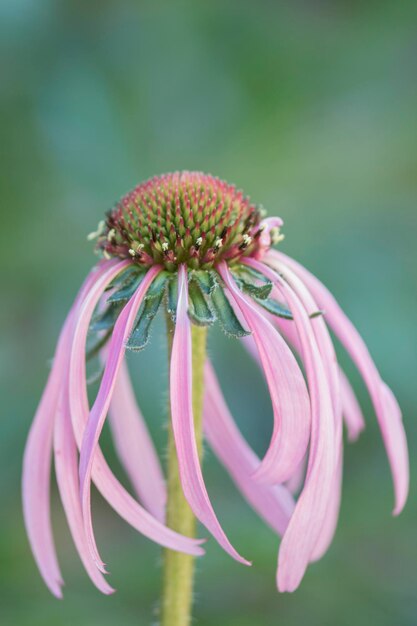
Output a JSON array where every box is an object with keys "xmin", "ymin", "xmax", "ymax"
[{"xmin": 170, "ymin": 265, "xmax": 250, "ymax": 565}]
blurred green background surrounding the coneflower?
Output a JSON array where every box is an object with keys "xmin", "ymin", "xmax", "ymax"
[{"xmin": 0, "ymin": 0, "xmax": 417, "ymax": 626}]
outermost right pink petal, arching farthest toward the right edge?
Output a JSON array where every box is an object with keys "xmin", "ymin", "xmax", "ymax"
[{"xmin": 268, "ymin": 251, "xmax": 409, "ymax": 515}]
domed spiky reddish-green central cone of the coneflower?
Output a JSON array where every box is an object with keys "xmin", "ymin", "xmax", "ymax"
[{"xmin": 98, "ymin": 172, "xmax": 262, "ymax": 271}]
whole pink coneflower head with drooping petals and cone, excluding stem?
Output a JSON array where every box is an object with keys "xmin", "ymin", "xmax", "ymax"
[{"xmin": 23, "ymin": 172, "xmax": 408, "ymax": 597}]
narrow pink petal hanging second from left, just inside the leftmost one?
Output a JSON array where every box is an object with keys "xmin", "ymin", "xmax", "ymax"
[{"xmin": 54, "ymin": 382, "xmax": 114, "ymax": 594}]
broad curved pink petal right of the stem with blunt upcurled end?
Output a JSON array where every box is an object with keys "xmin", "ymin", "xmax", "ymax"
[{"xmin": 219, "ymin": 263, "xmax": 310, "ymax": 483}]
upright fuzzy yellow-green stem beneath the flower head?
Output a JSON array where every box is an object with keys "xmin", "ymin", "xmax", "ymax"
[{"xmin": 161, "ymin": 317, "xmax": 207, "ymax": 626}]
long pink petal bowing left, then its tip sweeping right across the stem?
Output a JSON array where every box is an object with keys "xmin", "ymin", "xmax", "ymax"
[{"xmin": 68, "ymin": 262, "xmax": 204, "ymax": 566}]
